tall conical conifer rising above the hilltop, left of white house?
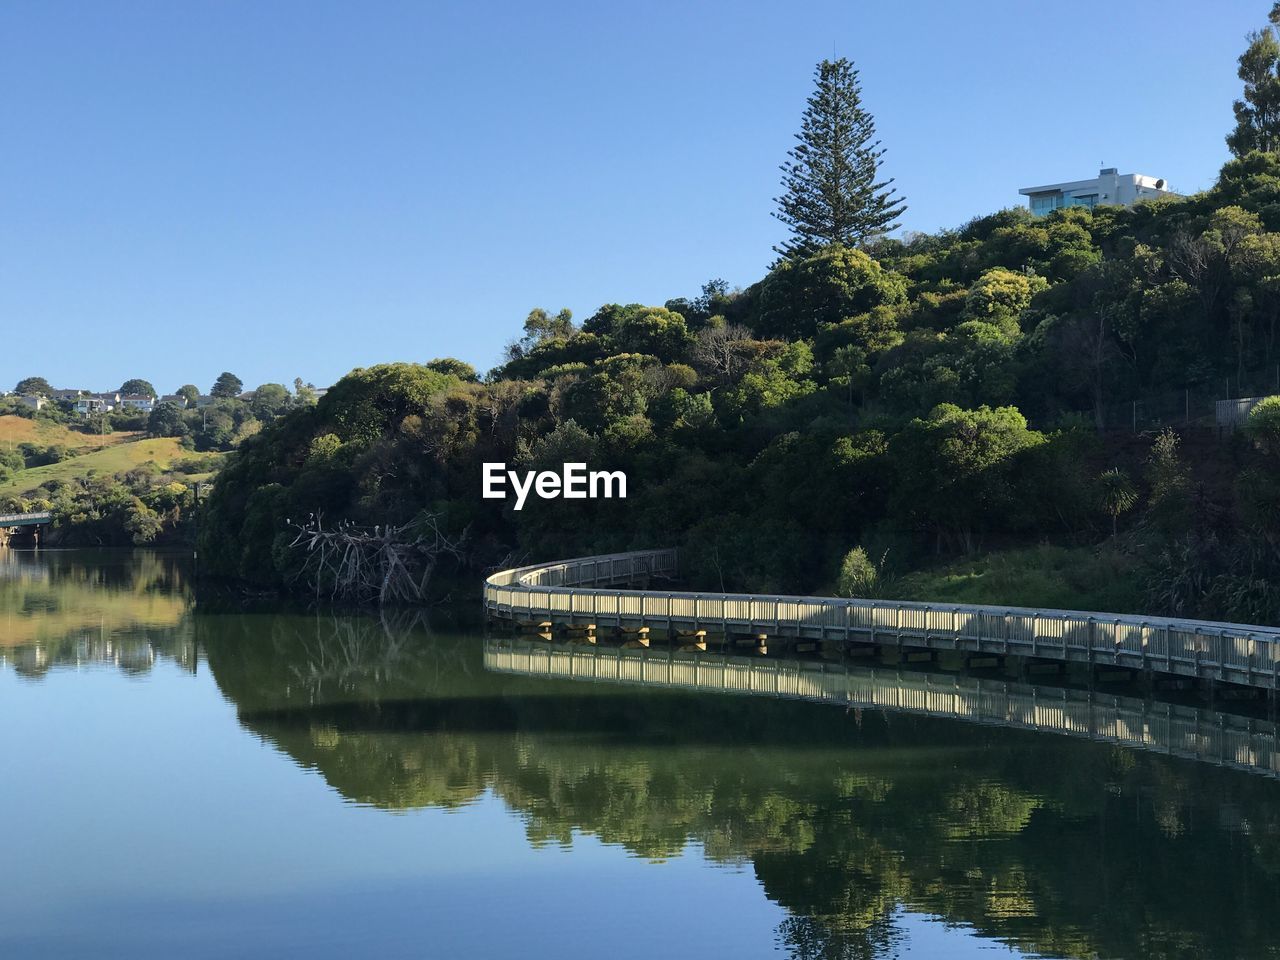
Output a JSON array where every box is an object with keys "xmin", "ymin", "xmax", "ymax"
[{"xmin": 774, "ymin": 58, "xmax": 906, "ymax": 259}]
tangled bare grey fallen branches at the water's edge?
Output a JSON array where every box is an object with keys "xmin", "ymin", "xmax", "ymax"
[{"xmin": 289, "ymin": 513, "xmax": 466, "ymax": 604}]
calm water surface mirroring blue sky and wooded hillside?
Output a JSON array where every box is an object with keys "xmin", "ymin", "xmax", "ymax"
[{"xmin": 0, "ymin": 553, "xmax": 1280, "ymax": 957}]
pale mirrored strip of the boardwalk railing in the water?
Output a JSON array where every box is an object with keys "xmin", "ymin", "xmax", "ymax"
[{"xmin": 484, "ymin": 639, "xmax": 1280, "ymax": 778}]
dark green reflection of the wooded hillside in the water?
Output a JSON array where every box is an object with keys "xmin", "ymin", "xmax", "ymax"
[{"xmin": 200, "ymin": 616, "xmax": 1280, "ymax": 957}]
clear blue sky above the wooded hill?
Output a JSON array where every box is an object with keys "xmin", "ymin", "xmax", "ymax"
[{"xmin": 0, "ymin": 0, "xmax": 1270, "ymax": 390}]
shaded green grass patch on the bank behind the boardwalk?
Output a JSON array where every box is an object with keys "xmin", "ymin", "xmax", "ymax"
[{"xmin": 884, "ymin": 544, "xmax": 1144, "ymax": 613}]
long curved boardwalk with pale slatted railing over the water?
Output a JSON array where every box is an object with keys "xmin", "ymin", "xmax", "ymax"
[{"xmin": 484, "ymin": 549, "xmax": 1280, "ymax": 691}]
